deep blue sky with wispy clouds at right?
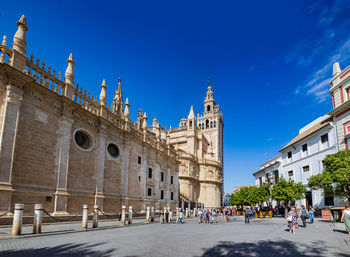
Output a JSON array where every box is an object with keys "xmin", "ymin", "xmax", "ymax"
[{"xmin": 0, "ymin": 0, "xmax": 350, "ymax": 192}]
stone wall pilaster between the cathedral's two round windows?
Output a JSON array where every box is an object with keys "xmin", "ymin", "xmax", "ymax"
[{"xmin": 95, "ymin": 124, "xmax": 107, "ymax": 209}]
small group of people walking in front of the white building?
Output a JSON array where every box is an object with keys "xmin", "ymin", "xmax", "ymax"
[{"xmin": 287, "ymin": 205, "xmax": 315, "ymax": 234}]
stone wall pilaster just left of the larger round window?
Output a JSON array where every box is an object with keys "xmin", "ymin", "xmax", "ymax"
[{"xmin": 53, "ymin": 108, "xmax": 73, "ymax": 215}]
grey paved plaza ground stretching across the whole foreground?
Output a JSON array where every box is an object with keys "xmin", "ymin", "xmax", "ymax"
[{"xmin": 0, "ymin": 217, "xmax": 350, "ymax": 257}]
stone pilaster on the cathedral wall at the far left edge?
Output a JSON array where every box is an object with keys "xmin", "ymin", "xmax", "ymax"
[{"xmin": 0, "ymin": 84, "xmax": 23, "ymax": 212}]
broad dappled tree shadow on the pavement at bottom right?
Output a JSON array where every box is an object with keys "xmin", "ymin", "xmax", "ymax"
[{"xmin": 198, "ymin": 240, "xmax": 350, "ymax": 257}]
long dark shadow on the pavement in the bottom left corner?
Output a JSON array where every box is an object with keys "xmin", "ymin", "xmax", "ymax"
[{"xmin": 0, "ymin": 243, "xmax": 117, "ymax": 257}]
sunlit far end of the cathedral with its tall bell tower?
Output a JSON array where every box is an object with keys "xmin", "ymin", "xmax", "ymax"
[{"xmin": 169, "ymin": 79, "xmax": 224, "ymax": 208}]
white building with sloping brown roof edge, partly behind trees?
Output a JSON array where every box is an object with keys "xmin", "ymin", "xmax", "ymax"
[{"xmin": 280, "ymin": 115, "xmax": 339, "ymax": 208}]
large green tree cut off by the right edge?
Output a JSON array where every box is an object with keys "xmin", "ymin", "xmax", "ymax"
[{"xmin": 308, "ymin": 150, "xmax": 350, "ymax": 202}]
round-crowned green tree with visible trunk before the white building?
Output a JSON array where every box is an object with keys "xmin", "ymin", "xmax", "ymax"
[{"xmin": 271, "ymin": 178, "xmax": 306, "ymax": 216}]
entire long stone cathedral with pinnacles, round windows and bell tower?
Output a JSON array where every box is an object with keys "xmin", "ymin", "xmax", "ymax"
[{"xmin": 0, "ymin": 16, "xmax": 223, "ymax": 216}]
